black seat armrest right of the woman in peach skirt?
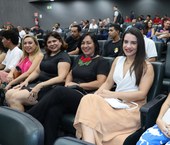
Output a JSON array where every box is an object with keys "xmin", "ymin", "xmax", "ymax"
[{"xmin": 140, "ymin": 94, "xmax": 167, "ymax": 130}]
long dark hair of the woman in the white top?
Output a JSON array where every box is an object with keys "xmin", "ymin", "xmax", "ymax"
[{"xmin": 122, "ymin": 27, "xmax": 146, "ymax": 86}]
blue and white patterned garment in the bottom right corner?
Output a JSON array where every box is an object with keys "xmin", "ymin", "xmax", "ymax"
[{"xmin": 136, "ymin": 125, "xmax": 170, "ymax": 145}]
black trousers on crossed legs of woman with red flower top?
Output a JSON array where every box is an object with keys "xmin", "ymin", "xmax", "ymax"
[{"xmin": 27, "ymin": 86, "xmax": 83, "ymax": 145}]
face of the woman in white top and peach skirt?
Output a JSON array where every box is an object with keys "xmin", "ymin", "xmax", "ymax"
[{"xmin": 123, "ymin": 33, "xmax": 137, "ymax": 57}]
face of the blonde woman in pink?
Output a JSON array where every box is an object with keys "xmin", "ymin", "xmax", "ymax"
[{"xmin": 23, "ymin": 37, "xmax": 38, "ymax": 54}]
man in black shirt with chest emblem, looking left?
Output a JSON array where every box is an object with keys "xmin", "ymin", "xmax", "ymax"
[{"xmin": 102, "ymin": 24, "xmax": 122, "ymax": 57}]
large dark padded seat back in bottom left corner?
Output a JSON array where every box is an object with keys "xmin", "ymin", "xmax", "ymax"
[{"xmin": 0, "ymin": 107, "xmax": 44, "ymax": 145}]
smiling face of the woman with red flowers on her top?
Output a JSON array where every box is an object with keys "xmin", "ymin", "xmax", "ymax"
[{"xmin": 81, "ymin": 35, "xmax": 95, "ymax": 56}]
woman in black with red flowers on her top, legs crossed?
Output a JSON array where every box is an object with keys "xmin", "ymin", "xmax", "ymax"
[{"xmin": 27, "ymin": 34, "xmax": 109, "ymax": 145}]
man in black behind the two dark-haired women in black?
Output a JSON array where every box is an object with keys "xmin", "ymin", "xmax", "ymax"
[{"xmin": 65, "ymin": 25, "xmax": 81, "ymax": 55}]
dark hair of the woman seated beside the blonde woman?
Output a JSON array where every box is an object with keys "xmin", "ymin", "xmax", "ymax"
[{"xmin": 44, "ymin": 31, "xmax": 68, "ymax": 55}]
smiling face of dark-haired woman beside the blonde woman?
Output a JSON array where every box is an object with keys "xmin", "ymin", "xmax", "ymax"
[{"xmin": 47, "ymin": 36, "xmax": 62, "ymax": 53}]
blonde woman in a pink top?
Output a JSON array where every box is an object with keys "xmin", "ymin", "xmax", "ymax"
[{"xmin": 5, "ymin": 35, "xmax": 43, "ymax": 90}]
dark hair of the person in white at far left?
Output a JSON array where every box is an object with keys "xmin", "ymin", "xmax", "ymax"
[{"xmin": 2, "ymin": 29, "xmax": 19, "ymax": 45}]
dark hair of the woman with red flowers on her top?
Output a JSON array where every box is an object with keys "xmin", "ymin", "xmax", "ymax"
[{"xmin": 78, "ymin": 33, "xmax": 100, "ymax": 55}]
